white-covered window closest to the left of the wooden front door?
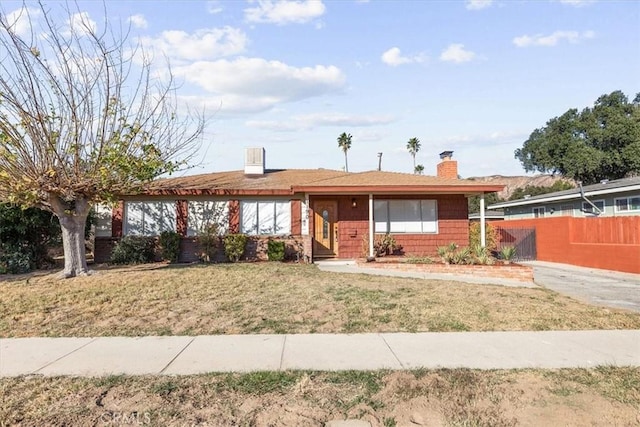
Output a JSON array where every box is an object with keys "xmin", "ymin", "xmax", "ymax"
[{"xmin": 240, "ymin": 200, "xmax": 291, "ymax": 235}]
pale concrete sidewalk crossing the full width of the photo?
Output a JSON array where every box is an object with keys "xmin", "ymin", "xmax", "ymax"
[{"xmin": 0, "ymin": 330, "xmax": 640, "ymax": 377}]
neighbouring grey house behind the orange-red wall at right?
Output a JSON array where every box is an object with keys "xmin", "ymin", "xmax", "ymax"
[{"xmin": 487, "ymin": 176, "xmax": 640, "ymax": 220}]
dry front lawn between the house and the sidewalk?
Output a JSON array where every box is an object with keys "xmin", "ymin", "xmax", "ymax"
[{"xmin": 0, "ymin": 263, "xmax": 640, "ymax": 337}]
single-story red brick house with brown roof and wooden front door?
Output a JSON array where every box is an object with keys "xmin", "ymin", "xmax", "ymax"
[{"xmin": 95, "ymin": 148, "xmax": 503, "ymax": 262}]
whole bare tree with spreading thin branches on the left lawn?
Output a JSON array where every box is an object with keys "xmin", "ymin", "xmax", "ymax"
[{"xmin": 0, "ymin": 3, "xmax": 205, "ymax": 277}]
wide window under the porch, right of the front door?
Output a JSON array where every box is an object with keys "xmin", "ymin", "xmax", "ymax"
[{"xmin": 373, "ymin": 200, "xmax": 438, "ymax": 233}]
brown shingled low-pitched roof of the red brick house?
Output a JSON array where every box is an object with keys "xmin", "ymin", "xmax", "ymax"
[{"xmin": 144, "ymin": 169, "xmax": 503, "ymax": 195}]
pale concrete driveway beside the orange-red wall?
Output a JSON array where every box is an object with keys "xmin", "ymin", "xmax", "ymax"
[{"xmin": 522, "ymin": 261, "xmax": 640, "ymax": 312}]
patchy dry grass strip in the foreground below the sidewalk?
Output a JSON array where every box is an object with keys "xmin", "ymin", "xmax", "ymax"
[{"xmin": 0, "ymin": 368, "xmax": 640, "ymax": 427}]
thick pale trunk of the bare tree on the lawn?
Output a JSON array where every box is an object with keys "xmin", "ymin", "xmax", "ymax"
[{"xmin": 51, "ymin": 196, "xmax": 89, "ymax": 278}]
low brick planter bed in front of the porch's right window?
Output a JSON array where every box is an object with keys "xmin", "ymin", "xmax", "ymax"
[{"xmin": 357, "ymin": 258, "xmax": 533, "ymax": 282}]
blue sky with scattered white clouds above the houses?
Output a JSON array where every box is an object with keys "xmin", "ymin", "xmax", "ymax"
[{"xmin": 3, "ymin": 0, "xmax": 640, "ymax": 177}]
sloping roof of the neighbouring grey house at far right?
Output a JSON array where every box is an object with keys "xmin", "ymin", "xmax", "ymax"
[{"xmin": 487, "ymin": 176, "xmax": 640, "ymax": 209}]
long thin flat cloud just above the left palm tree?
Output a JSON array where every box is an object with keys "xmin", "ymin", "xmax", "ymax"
[{"xmin": 246, "ymin": 113, "xmax": 395, "ymax": 132}]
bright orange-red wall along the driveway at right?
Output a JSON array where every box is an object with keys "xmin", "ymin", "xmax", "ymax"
[{"xmin": 499, "ymin": 216, "xmax": 640, "ymax": 273}]
